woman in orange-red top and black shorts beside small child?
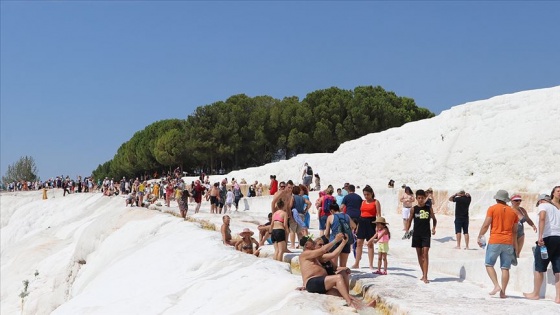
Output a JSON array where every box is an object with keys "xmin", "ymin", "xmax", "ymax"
[{"xmin": 352, "ymin": 185, "xmax": 381, "ymax": 270}]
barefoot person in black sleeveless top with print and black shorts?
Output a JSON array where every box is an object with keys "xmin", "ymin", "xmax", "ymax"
[{"xmin": 406, "ymin": 189, "xmax": 437, "ymax": 283}]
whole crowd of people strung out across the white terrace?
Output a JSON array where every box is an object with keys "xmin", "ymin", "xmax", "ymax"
[{"xmin": 10, "ymin": 163, "xmax": 560, "ymax": 308}]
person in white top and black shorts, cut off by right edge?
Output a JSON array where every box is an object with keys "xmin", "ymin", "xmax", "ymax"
[{"xmin": 523, "ymin": 194, "xmax": 560, "ymax": 304}]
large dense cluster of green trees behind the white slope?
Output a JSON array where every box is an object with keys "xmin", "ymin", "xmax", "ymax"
[{"xmin": 93, "ymin": 86, "xmax": 434, "ymax": 178}]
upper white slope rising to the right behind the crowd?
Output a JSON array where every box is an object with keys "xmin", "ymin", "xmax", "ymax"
[{"xmin": 228, "ymin": 87, "xmax": 560, "ymax": 192}]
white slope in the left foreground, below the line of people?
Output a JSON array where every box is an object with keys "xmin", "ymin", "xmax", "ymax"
[{"xmin": 0, "ymin": 191, "xmax": 349, "ymax": 315}]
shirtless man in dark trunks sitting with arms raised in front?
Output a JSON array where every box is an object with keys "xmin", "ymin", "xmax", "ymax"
[{"xmin": 299, "ymin": 233, "xmax": 362, "ymax": 309}]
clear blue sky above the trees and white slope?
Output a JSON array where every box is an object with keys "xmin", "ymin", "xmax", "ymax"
[{"xmin": 0, "ymin": 1, "xmax": 560, "ymax": 179}]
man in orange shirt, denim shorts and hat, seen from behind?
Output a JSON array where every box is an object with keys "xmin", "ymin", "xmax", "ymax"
[{"xmin": 478, "ymin": 190, "xmax": 519, "ymax": 299}]
